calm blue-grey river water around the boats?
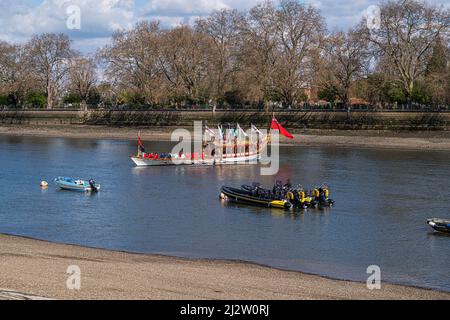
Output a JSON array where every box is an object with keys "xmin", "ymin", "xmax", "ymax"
[{"xmin": 0, "ymin": 136, "xmax": 450, "ymax": 291}]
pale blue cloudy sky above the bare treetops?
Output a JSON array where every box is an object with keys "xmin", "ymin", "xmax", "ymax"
[{"xmin": 0, "ymin": 0, "xmax": 450, "ymax": 53}]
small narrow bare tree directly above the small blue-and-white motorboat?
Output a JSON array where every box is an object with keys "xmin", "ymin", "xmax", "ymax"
[{"xmin": 69, "ymin": 57, "xmax": 97, "ymax": 110}]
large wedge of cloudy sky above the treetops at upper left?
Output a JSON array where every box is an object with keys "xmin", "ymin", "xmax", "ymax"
[{"xmin": 0, "ymin": 0, "xmax": 264, "ymax": 52}]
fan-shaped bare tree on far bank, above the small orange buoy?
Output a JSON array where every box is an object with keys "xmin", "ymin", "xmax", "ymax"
[{"xmin": 26, "ymin": 33, "xmax": 74, "ymax": 109}]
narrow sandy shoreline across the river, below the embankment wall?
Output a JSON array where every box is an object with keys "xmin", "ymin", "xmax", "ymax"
[{"xmin": 0, "ymin": 125, "xmax": 450, "ymax": 151}]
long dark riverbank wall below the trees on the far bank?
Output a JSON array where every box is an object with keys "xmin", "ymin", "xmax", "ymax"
[{"xmin": 0, "ymin": 110, "xmax": 450, "ymax": 131}]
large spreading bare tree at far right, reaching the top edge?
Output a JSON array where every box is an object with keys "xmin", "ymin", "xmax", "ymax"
[{"xmin": 364, "ymin": 0, "xmax": 450, "ymax": 104}]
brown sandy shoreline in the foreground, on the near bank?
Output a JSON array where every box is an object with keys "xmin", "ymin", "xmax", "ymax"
[{"xmin": 0, "ymin": 235, "xmax": 450, "ymax": 300}]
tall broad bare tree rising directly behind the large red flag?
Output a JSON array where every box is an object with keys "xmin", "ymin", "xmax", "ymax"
[{"xmin": 244, "ymin": 0, "xmax": 325, "ymax": 107}]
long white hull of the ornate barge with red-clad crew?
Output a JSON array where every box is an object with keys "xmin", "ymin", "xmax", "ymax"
[{"xmin": 131, "ymin": 154, "xmax": 261, "ymax": 167}]
